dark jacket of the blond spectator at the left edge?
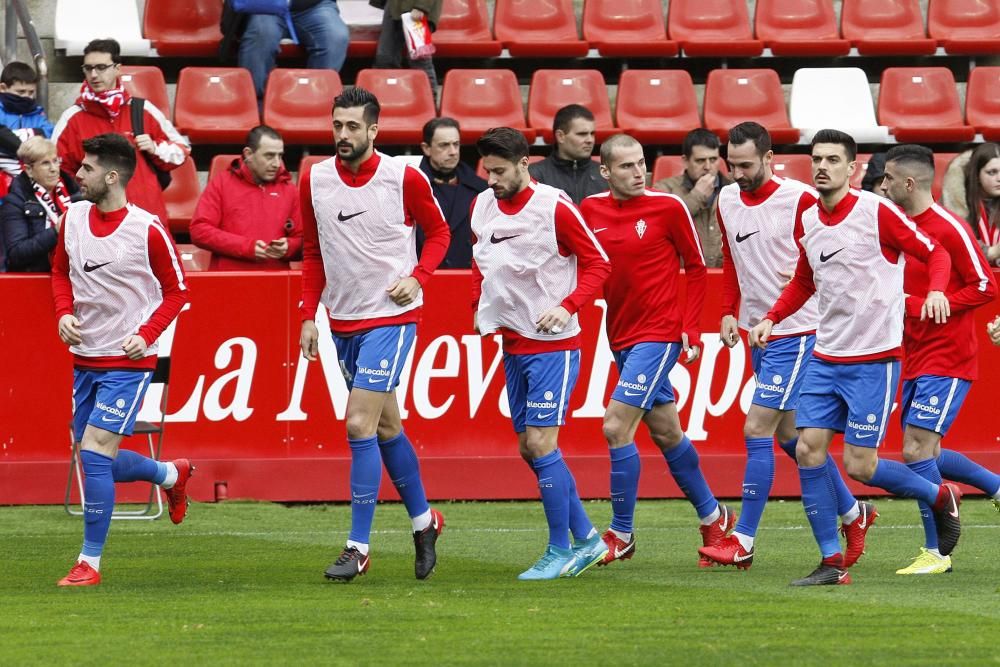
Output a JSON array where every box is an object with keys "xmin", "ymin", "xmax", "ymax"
[{"xmin": 0, "ymin": 172, "xmax": 80, "ymax": 273}]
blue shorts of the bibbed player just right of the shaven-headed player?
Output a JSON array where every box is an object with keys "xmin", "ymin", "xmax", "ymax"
[{"xmin": 750, "ymin": 334, "xmax": 816, "ymax": 411}]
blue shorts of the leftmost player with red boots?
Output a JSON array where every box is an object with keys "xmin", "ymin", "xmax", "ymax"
[{"xmin": 73, "ymin": 370, "xmax": 153, "ymax": 442}]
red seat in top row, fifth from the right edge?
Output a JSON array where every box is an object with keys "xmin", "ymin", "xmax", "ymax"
[{"xmin": 583, "ymin": 0, "xmax": 677, "ymax": 58}]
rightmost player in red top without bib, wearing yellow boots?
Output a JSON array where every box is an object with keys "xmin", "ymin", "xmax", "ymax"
[{"xmin": 881, "ymin": 145, "xmax": 1000, "ymax": 575}]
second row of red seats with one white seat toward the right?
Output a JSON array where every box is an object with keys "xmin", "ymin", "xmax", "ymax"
[{"xmin": 123, "ymin": 66, "xmax": 1000, "ymax": 145}]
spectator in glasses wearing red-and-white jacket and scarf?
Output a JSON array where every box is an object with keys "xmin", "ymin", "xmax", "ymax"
[{"xmin": 52, "ymin": 39, "xmax": 191, "ymax": 224}]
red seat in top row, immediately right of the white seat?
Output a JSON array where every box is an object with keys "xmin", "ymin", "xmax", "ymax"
[{"xmin": 142, "ymin": 0, "xmax": 222, "ymax": 57}]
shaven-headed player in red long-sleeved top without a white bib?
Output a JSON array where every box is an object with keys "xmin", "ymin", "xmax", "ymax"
[{"xmin": 580, "ymin": 134, "xmax": 736, "ymax": 567}]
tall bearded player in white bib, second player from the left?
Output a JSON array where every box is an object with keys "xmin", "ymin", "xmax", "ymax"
[{"xmin": 299, "ymin": 87, "xmax": 451, "ymax": 582}]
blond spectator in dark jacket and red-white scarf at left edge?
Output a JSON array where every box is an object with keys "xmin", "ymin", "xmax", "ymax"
[{"xmin": 0, "ymin": 137, "xmax": 79, "ymax": 273}]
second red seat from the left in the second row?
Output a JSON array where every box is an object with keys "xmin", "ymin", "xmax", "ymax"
[{"xmin": 174, "ymin": 67, "xmax": 260, "ymax": 144}]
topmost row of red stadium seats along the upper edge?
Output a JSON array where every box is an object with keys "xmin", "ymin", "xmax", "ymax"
[{"xmin": 127, "ymin": 0, "xmax": 1000, "ymax": 58}]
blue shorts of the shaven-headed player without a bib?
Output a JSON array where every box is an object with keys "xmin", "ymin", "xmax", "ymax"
[{"xmin": 611, "ymin": 343, "xmax": 681, "ymax": 410}]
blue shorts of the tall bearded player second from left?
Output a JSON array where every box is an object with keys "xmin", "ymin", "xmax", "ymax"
[{"xmin": 333, "ymin": 323, "xmax": 417, "ymax": 392}]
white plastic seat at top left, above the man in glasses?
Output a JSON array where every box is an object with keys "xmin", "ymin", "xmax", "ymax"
[{"xmin": 55, "ymin": 0, "xmax": 151, "ymax": 57}]
